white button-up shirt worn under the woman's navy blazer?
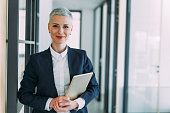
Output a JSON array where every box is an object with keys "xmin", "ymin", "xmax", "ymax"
[{"xmin": 45, "ymin": 46, "xmax": 85, "ymax": 113}]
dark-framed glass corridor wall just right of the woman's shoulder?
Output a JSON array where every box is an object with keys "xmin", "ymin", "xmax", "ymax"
[{"xmin": 93, "ymin": 3, "xmax": 107, "ymax": 104}]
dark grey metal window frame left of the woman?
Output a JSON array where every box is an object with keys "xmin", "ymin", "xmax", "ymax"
[{"xmin": 6, "ymin": 0, "xmax": 39, "ymax": 113}]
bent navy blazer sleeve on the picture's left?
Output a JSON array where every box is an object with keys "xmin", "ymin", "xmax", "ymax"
[{"xmin": 18, "ymin": 56, "xmax": 48, "ymax": 111}]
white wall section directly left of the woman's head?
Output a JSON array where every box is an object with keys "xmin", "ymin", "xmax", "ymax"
[{"xmin": 39, "ymin": 0, "xmax": 52, "ymax": 51}]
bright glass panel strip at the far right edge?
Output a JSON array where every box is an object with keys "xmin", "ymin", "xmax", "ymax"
[{"xmin": 159, "ymin": 0, "xmax": 170, "ymax": 113}]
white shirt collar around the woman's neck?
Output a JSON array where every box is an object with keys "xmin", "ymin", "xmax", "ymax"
[{"xmin": 50, "ymin": 46, "xmax": 68, "ymax": 59}]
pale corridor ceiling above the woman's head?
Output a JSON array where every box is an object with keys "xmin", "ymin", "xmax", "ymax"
[{"xmin": 53, "ymin": 0, "xmax": 104, "ymax": 10}]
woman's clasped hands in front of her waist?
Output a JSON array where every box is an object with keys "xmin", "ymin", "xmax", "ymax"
[{"xmin": 50, "ymin": 96, "xmax": 78, "ymax": 112}]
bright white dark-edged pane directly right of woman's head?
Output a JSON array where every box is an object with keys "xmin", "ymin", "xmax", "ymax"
[{"xmin": 67, "ymin": 12, "xmax": 81, "ymax": 48}]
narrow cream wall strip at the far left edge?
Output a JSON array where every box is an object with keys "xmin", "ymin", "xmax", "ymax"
[{"xmin": 0, "ymin": 0, "xmax": 7, "ymax": 113}]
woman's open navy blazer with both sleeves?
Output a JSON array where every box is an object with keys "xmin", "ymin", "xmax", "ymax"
[{"xmin": 18, "ymin": 47, "xmax": 99, "ymax": 113}]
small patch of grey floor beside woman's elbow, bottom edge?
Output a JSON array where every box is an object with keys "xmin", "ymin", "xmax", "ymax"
[{"xmin": 87, "ymin": 99, "xmax": 104, "ymax": 113}]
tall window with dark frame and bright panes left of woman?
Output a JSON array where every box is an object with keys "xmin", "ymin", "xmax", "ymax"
[{"xmin": 7, "ymin": 0, "xmax": 39, "ymax": 113}]
